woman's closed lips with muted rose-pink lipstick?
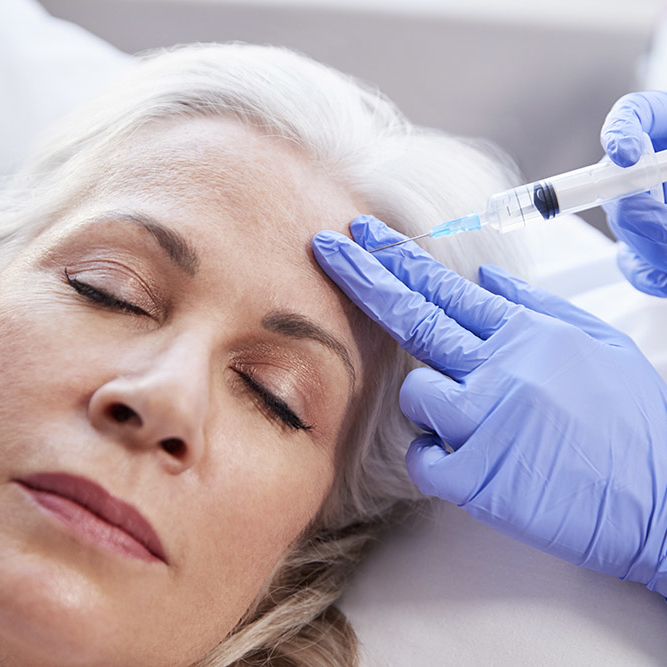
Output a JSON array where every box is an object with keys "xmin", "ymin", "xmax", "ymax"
[{"xmin": 14, "ymin": 472, "xmax": 168, "ymax": 563}]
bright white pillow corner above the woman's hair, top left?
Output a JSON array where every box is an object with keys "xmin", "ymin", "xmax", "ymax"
[{"xmin": 0, "ymin": 0, "xmax": 132, "ymax": 176}]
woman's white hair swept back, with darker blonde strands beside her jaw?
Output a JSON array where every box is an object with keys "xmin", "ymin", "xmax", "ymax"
[{"xmin": 0, "ymin": 44, "xmax": 521, "ymax": 667}]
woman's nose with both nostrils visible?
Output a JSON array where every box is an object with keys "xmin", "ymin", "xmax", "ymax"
[{"xmin": 88, "ymin": 338, "xmax": 209, "ymax": 474}]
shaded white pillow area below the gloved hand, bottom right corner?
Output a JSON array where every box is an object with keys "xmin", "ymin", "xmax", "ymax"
[{"xmin": 341, "ymin": 502, "xmax": 667, "ymax": 667}]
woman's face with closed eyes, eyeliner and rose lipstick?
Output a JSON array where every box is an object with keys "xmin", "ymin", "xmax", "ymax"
[{"xmin": 0, "ymin": 119, "xmax": 369, "ymax": 667}]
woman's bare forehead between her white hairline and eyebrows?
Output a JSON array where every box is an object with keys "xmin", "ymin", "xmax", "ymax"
[{"xmin": 100, "ymin": 118, "xmax": 359, "ymax": 261}]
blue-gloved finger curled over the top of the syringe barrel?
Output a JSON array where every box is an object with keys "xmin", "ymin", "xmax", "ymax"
[{"xmin": 600, "ymin": 90, "xmax": 667, "ymax": 167}]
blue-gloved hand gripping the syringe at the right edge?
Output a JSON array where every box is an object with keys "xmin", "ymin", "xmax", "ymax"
[{"xmin": 600, "ymin": 90, "xmax": 667, "ymax": 296}]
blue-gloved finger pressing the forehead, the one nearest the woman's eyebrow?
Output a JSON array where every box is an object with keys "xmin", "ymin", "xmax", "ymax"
[{"xmin": 313, "ymin": 231, "xmax": 485, "ymax": 379}]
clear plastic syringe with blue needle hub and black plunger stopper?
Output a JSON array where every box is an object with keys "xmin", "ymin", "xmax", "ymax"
[{"xmin": 371, "ymin": 150, "xmax": 667, "ymax": 252}]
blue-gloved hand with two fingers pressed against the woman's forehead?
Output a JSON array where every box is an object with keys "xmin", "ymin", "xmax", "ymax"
[{"xmin": 313, "ymin": 216, "xmax": 667, "ymax": 595}]
